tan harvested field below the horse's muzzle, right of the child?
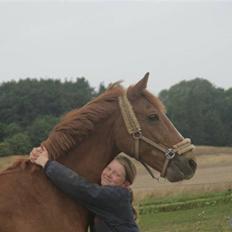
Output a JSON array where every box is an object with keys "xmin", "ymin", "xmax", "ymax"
[{"xmin": 133, "ymin": 146, "xmax": 232, "ymax": 199}]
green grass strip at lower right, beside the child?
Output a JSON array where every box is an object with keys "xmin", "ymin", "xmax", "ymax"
[{"xmin": 138, "ymin": 191, "xmax": 232, "ymax": 232}]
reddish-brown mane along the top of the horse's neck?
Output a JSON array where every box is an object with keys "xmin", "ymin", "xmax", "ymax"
[{"xmin": 42, "ymin": 83, "xmax": 124, "ymax": 159}]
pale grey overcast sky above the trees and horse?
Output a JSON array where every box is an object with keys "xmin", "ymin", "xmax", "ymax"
[{"xmin": 0, "ymin": 0, "xmax": 232, "ymax": 93}]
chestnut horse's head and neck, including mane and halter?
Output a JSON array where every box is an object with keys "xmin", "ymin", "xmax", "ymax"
[{"xmin": 43, "ymin": 74, "xmax": 197, "ymax": 182}]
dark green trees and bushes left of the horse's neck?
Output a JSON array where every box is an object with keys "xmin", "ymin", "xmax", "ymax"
[{"xmin": 0, "ymin": 77, "xmax": 105, "ymax": 156}]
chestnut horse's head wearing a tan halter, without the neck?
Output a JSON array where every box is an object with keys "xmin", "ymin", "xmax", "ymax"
[{"xmin": 115, "ymin": 73, "xmax": 197, "ymax": 182}]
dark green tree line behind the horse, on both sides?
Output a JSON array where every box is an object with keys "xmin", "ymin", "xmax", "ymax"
[{"xmin": 0, "ymin": 77, "xmax": 232, "ymax": 156}]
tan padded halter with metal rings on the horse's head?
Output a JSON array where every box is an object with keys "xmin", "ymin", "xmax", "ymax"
[{"xmin": 119, "ymin": 92, "xmax": 194, "ymax": 179}]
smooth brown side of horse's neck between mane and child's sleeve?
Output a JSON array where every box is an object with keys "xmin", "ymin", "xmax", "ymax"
[{"xmin": 55, "ymin": 120, "xmax": 119, "ymax": 182}]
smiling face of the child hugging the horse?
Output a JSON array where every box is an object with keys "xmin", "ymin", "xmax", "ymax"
[{"xmin": 101, "ymin": 160, "xmax": 130, "ymax": 187}]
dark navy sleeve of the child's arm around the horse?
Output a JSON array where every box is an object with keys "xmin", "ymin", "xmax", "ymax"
[{"xmin": 44, "ymin": 160, "xmax": 128, "ymax": 215}]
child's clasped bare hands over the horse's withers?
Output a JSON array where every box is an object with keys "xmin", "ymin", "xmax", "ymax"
[{"xmin": 30, "ymin": 146, "xmax": 49, "ymax": 167}]
